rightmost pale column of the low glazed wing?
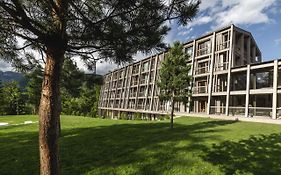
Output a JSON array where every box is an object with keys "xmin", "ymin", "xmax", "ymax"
[{"xmin": 272, "ymin": 60, "xmax": 278, "ymax": 119}]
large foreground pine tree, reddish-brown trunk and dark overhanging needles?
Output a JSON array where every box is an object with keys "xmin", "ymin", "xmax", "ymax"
[{"xmin": 0, "ymin": 0, "xmax": 199, "ymax": 174}]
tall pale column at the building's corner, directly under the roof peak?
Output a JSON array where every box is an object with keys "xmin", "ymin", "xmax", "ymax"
[{"xmin": 225, "ymin": 25, "xmax": 235, "ymax": 115}]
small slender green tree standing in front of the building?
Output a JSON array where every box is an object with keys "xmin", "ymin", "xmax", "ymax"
[{"xmin": 157, "ymin": 42, "xmax": 191, "ymax": 129}]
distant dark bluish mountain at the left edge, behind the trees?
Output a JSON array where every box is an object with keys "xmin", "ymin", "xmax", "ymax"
[{"xmin": 0, "ymin": 71, "xmax": 26, "ymax": 87}]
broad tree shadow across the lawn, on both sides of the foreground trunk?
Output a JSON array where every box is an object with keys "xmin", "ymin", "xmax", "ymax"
[{"xmin": 0, "ymin": 121, "xmax": 235, "ymax": 175}]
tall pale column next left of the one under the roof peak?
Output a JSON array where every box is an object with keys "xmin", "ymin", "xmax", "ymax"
[{"xmin": 207, "ymin": 32, "xmax": 216, "ymax": 115}]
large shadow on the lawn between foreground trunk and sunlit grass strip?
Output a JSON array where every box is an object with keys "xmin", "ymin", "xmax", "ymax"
[{"xmin": 61, "ymin": 121, "xmax": 235, "ymax": 175}]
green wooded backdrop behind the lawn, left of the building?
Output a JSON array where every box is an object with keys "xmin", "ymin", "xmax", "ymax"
[{"xmin": 0, "ymin": 59, "xmax": 102, "ymax": 117}]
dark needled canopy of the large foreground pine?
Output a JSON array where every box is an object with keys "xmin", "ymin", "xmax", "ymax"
[{"xmin": 0, "ymin": 0, "xmax": 199, "ymax": 66}]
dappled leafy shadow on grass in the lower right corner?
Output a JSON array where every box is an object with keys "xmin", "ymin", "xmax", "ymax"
[{"xmin": 204, "ymin": 133, "xmax": 281, "ymax": 175}]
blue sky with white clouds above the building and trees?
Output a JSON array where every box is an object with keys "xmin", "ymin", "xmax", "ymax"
[{"xmin": 0, "ymin": 0, "xmax": 281, "ymax": 74}]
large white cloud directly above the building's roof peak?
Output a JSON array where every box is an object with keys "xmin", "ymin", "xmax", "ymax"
[{"xmin": 174, "ymin": 0, "xmax": 280, "ymax": 38}]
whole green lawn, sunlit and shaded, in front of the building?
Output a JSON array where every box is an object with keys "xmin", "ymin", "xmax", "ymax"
[{"xmin": 0, "ymin": 116, "xmax": 281, "ymax": 175}]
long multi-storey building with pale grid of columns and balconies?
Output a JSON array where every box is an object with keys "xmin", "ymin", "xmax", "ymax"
[{"xmin": 99, "ymin": 25, "xmax": 281, "ymax": 119}]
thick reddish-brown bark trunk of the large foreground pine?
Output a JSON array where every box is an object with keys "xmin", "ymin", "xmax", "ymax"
[{"xmin": 39, "ymin": 47, "xmax": 65, "ymax": 175}]
